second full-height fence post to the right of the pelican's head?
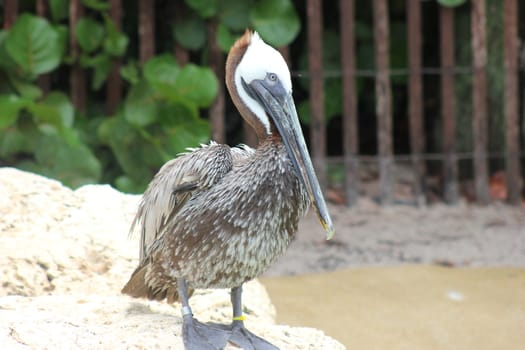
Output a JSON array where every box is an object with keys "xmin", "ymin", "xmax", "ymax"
[{"xmin": 339, "ymin": 0, "xmax": 360, "ymax": 206}]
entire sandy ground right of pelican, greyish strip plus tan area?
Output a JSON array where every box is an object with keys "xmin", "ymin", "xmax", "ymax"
[{"xmin": 262, "ymin": 199, "xmax": 525, "ymax": 350}]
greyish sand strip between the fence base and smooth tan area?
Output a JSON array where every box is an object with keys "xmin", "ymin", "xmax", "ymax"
[{"xmin": 266, "ymin": 199, "xmax": 525, "ymax": 276}]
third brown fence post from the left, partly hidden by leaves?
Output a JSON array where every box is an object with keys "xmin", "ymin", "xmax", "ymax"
[{"xmin": 69, "ymin": 0, "xmax": 86, "ymax": 112}]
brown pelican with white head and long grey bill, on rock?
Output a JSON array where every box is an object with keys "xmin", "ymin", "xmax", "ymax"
[{"xmin": 122, "ymin": 31, "xmax": 334, "ymax": 349}]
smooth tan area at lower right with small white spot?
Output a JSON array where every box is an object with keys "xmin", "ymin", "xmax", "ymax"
[{"xmin": 261, "ymin": 265, "xmax": 525, "ymax": 350}]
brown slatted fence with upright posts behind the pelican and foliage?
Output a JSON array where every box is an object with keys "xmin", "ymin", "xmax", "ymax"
[{"xmin": 4, "ymin": 0, "xmax": 522, "ymax": 205}]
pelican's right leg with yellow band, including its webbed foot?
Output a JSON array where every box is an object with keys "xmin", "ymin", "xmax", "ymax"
[{"xmin": 229, "ymin": 286, "xmax": 279, "ymax": 350}]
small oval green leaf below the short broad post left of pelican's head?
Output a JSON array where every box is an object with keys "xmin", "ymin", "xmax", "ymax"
[{"xmin": 124, "ymin": 81, "xmax": 158, "ymax": 126}]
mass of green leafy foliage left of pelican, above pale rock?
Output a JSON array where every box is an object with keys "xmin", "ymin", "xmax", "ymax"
[{"xmin": 0, "ymin": 6, "xmax": 218, "ymax": 192}]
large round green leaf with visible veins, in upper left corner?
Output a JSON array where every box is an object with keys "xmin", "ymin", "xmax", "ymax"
[{"xmin": 5, "ymin": 14, "xmax": 65, "ymax": 79}]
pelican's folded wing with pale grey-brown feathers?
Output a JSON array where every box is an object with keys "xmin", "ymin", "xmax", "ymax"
[{"xmin": 130, "ymin": 142, "xmax": 233, "ymax": 264}]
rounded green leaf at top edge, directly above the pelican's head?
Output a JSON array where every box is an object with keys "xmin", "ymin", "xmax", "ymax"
[{"xmin": 250, "ymin": 0, "xmax": 301, "ymax": 47}]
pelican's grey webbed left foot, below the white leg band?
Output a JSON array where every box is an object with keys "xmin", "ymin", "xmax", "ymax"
[{"xmin": 182, "ymin": 315, "xmax": 232, "ymax": 350}]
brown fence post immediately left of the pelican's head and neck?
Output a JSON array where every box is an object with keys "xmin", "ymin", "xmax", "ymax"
[{"xmin": 208, "ymin": 20, "xmax": 226, "ymax": 143}]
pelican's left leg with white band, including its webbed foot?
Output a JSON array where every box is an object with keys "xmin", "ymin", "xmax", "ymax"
[{"xmin": 177, "ymin": 278, "xmax": 231, "ymax": 350}]
